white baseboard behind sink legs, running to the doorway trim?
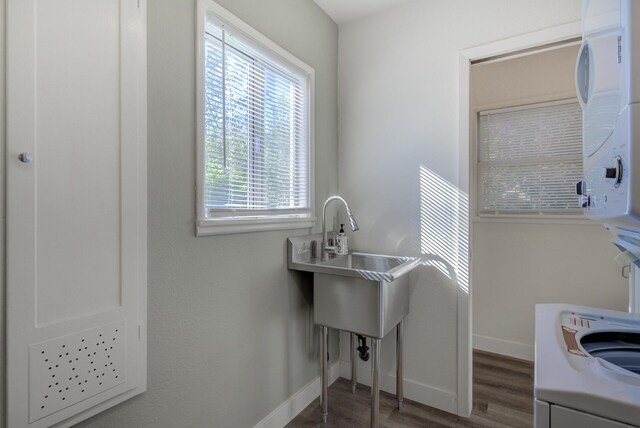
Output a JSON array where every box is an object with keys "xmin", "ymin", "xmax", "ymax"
[{"xmin": 340, "ymin": 360, "xmax": 458, "ymax": 414}]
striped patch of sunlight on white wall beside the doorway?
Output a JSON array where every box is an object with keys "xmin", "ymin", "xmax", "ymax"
[{"xmin": 420, "ymin": 165, "xmax": 469, "ymax": 294}]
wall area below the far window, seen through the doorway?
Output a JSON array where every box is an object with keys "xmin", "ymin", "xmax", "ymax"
[{"xmin": 473, "ymin": 223, "xmax": 628, "ymax": 360}]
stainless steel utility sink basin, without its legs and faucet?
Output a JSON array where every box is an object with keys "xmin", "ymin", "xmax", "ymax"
[{"xmin": 287, "ymin": 234, "xmax": 420, "ymax": 338}]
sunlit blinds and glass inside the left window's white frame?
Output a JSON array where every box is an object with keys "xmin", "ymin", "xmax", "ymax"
[{"xmin": 204, "ymin": 26, "xmax": 309, "ymax": 216}]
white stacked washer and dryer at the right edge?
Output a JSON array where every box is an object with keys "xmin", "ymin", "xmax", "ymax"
[{"xmin": 534, "ymin": 0, "xmax": 640, "ymax": 428}]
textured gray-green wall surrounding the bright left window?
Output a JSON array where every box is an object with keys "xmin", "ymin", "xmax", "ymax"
[{"xmin": 0, "ymin": 0, "xmax": 338, "ymax": 428}]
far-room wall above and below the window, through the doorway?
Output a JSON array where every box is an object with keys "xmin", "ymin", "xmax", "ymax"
[{"xmin": 470, "ymin": 46, "xmax": 628, "ymax": 360}]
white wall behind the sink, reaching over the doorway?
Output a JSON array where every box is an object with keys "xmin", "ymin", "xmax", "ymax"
[{"xmin": 338, "ymin": 0, "xmax": 581, "ymax": 410}]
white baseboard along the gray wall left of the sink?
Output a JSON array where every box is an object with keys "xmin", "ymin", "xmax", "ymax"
[{"xmin": 253, "ymin": 361, "xmax": 340, "ymax": 428}]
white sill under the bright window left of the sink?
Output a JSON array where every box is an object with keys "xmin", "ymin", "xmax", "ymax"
[{"xmin": 196, "ymin": 217, "xmax": 316, "ymax": 236}]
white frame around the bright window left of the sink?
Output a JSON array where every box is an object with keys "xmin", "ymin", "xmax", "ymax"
[{"xmin": 196, "ymin": 0, "xmax": 316, "ymax": 236}]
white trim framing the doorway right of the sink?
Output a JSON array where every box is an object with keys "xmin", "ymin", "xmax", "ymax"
[{"xmin": 457, "ymin": 21, "xmax": 582, "ymax": 417}]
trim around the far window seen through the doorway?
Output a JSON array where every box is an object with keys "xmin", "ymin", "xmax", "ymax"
[{"xmin": 469, "ymin": 92, "xmax": 594, "ymax": 225}]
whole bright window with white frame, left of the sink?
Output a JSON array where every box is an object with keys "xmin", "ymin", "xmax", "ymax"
[{"xmin": 198, "ymin": 0, "xmax": 314, "ymax": 235}]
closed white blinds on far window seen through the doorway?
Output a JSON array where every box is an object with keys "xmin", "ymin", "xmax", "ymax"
[{"xmin": 477, "ymin": 99, "xmax": 582, "ymax": 216}]
